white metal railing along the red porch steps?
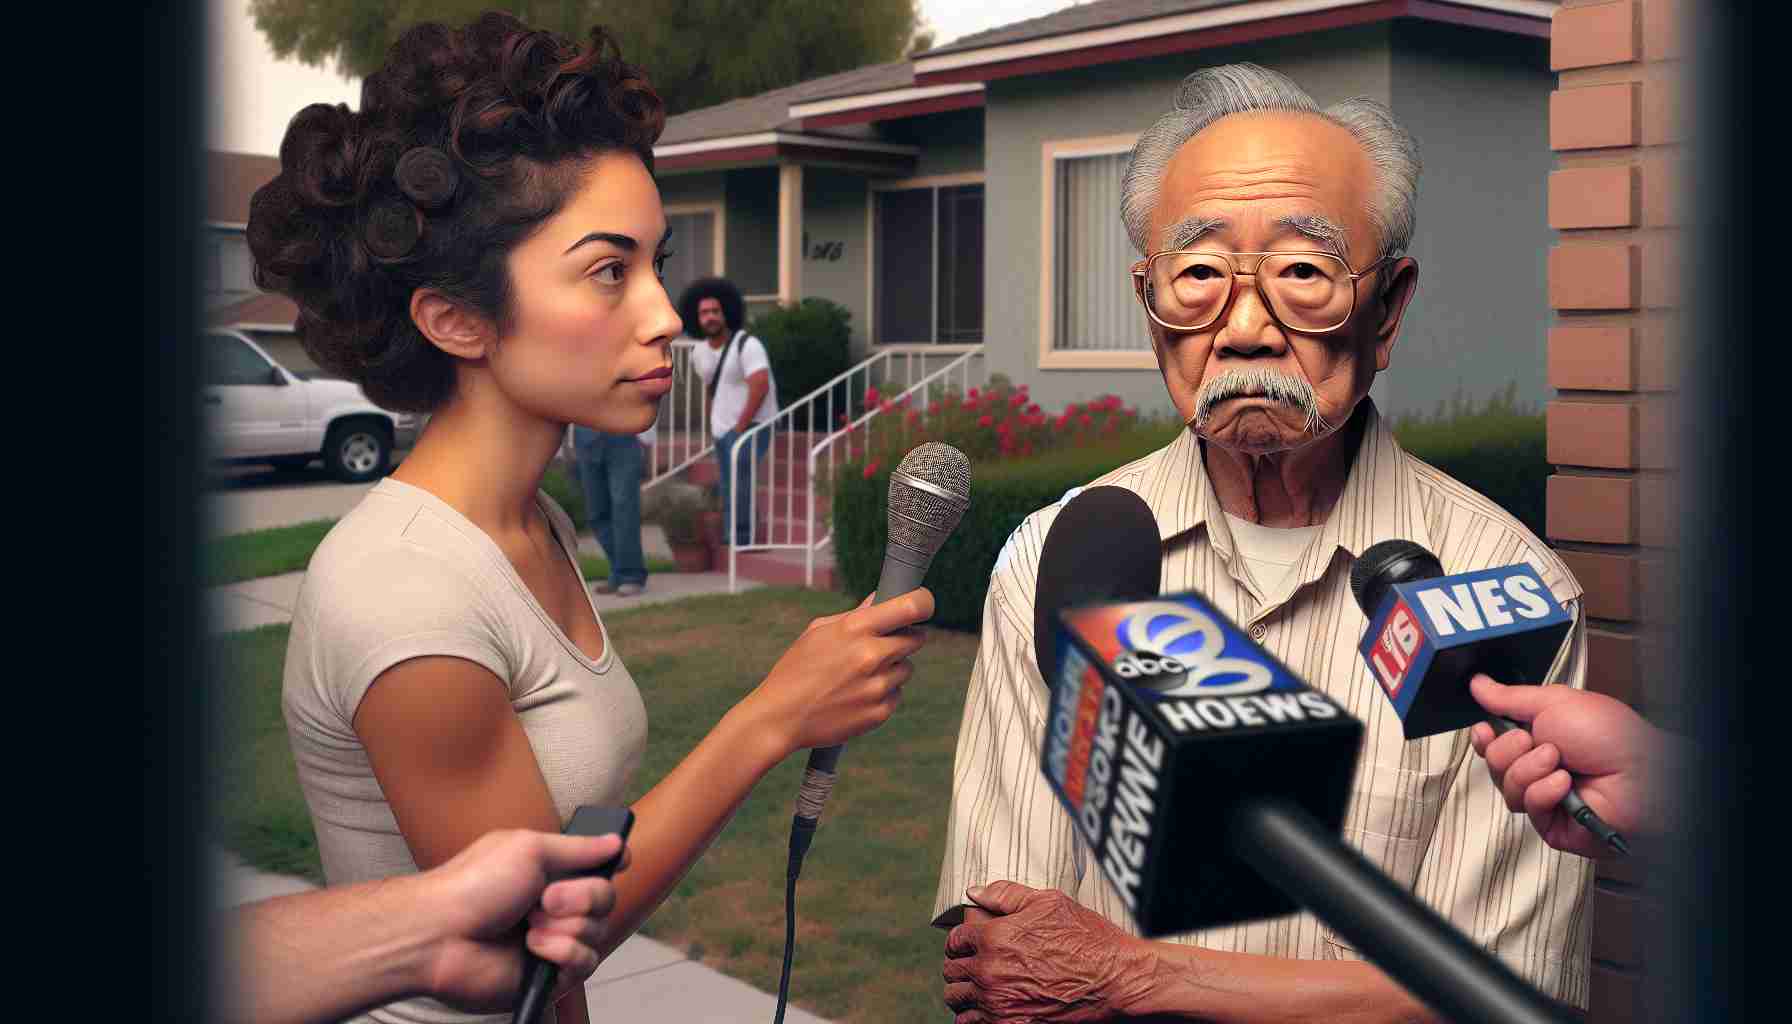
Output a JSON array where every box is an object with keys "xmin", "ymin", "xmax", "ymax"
[{"xmin": 720, "ymin": 348, "xmax": 984, "ymax": 594}]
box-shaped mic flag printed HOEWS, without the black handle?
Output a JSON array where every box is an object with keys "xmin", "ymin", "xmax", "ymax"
[{"xmin": 1043, "ymin": 592, "xmax": 1362, "ymax": 936}]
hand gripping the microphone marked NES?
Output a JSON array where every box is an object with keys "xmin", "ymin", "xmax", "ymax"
[{"xmin": 1469, "ymin": 674, "xmax": 1665, "ymax": 857}]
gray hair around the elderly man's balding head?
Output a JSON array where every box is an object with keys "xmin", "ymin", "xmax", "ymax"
[{"xmin": 1120, "ymin": 65, "xmax": 1419, "ymax": 256}]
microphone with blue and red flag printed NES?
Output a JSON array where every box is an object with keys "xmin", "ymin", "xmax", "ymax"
[{"xmin": 1349, "ymin": 540, "xmax": 1631, "ymax": 855}]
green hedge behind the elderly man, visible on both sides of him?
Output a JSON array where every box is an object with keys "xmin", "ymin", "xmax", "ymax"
[{"xmin": 833, "ymin": 391, "xmax": 1550, "ymax": 629}]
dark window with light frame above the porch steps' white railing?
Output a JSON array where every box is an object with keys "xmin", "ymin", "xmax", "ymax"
[{"xmin": 873, "ymin": 185, "xmax": 984, "ymax": 344}]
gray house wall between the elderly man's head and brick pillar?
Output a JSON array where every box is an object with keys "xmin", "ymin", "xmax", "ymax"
[{"xmin": 1376, "ymin": 22, "xmax": 1555, "ymax": 412}]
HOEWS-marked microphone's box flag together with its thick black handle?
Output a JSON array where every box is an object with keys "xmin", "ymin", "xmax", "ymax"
[{"xmin": 1041, "ymin": 534, "xmax": 1563, "ymax": 1024}]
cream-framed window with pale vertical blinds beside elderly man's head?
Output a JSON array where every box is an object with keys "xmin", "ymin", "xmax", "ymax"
[{"xmin": 1050, "ymin": 152, "xmax": 1150, "ymax": 351}]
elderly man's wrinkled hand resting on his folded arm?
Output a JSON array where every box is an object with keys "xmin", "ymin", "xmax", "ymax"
[{"xmin": 941, "ymin": 882, "xmax": 1154, "ymax": 1024}]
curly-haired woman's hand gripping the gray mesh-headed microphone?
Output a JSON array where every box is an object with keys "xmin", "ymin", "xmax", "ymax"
[{"xmin": 747, "ymin": 586, "xmax": 934, "ymax": 751}]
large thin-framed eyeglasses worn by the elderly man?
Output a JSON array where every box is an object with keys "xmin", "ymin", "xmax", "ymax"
[{"xmin": 1133, "ymin": 249, "xmax": 1394, "ymax": 334}]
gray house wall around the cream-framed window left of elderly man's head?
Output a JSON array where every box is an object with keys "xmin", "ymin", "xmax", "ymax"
[{"xmin": 984, "ymin": 25, "xmax": 1391, "ymax": 412}]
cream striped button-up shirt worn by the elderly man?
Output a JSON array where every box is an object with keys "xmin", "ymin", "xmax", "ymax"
[{"xmin": 934, "ymin": 398, "xmax": 1593, "ymax": 1008}]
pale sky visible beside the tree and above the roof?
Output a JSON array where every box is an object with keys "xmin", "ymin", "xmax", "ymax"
[{"xmin": 206, "ymin": 0, "xmax": 1072, "ymax": 156}]
